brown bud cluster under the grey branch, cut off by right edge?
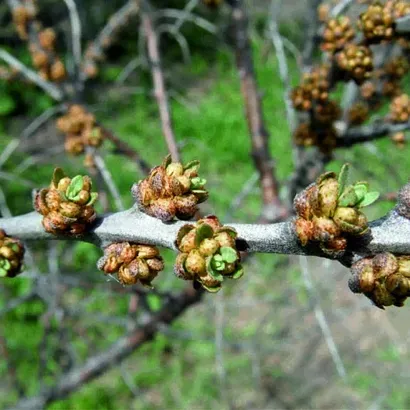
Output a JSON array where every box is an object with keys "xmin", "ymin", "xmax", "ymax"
[{"xmin": 349, "ymin": 252, "xmax": 410, "ymax": 309}]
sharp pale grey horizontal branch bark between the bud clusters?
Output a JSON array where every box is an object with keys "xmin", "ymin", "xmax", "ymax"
[{"xmin": 0, "ymin": 204, "xmax": 410, "ymax": 265}]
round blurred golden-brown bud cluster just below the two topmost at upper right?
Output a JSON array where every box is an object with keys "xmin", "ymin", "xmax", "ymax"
[{"xmin": 336, "ymin": 43, "xmax": 373, "ymax": 84}]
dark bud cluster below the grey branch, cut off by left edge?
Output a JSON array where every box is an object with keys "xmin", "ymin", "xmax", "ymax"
[{"xmin": 0, "ymin": 229, "xmax": 24, "ymax": 278}]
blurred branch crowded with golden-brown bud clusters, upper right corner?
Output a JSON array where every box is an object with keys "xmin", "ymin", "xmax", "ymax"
[{"xmin": 292, "ymin": 0, "xmax": 410, "ymax": 156}]
